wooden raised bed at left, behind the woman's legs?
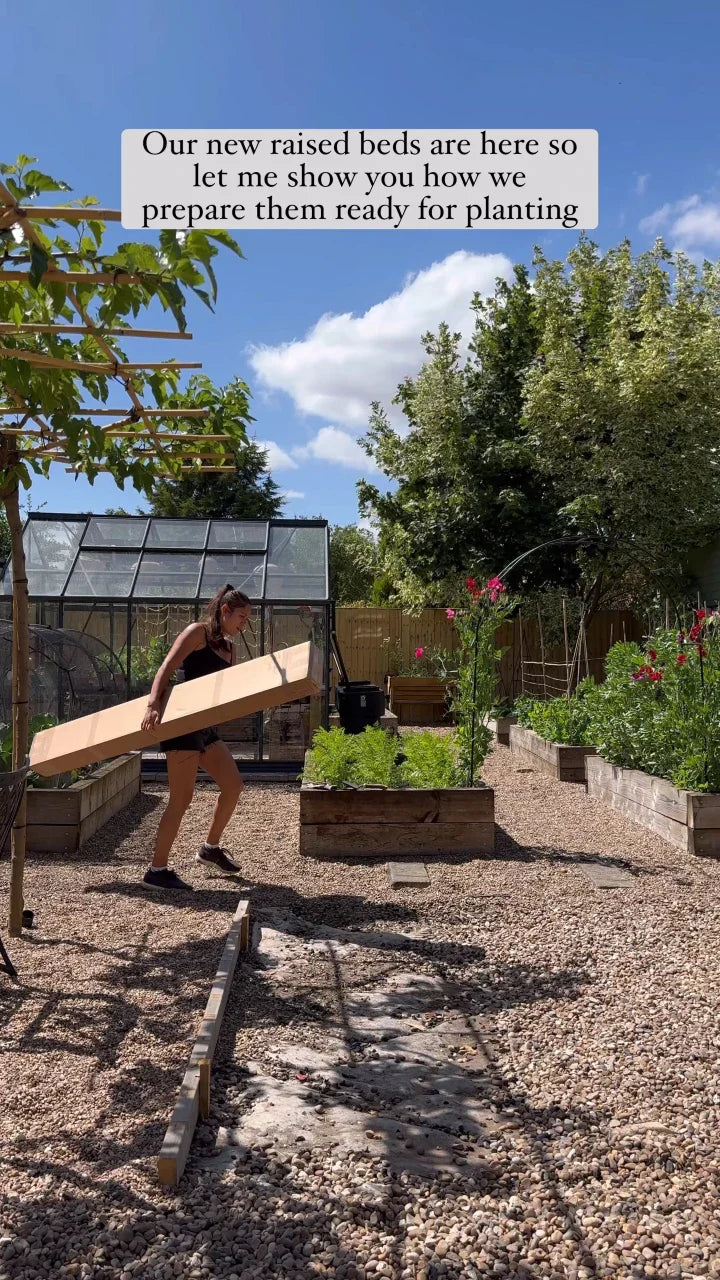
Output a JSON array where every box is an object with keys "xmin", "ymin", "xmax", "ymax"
[{"xmin": 27, "ymin": 751, "xmax": 141, "ymax": 854}]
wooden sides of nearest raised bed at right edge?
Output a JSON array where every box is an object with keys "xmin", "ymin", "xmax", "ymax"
[{"xmin": 587, "ymin": 755, "xmax": 720, "ymax": 858}]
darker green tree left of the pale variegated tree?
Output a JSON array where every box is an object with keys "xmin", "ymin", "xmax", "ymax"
[{"xmin": 357, "ymin": 266, "xmax": 566, "ymax": 608}]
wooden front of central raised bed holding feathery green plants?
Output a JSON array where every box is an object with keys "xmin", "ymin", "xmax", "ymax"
[{"xmin": 300, "ymin": 757, "xmax": 495, "ymax": 858}]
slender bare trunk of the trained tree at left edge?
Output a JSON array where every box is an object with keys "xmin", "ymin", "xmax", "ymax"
[{"xmin": 3, "ymin": 481, "xmax": 29, "ymax": 938}]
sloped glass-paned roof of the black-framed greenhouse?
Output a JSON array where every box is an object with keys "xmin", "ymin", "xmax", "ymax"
[{"xmin": 0, "ymin": 512, "xmax": 329, "ymax": 604}]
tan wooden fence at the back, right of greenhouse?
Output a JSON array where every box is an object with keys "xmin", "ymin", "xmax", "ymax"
[{"xmin": 333, "ymin": 608, "xmax": 643, "ymax": 699}]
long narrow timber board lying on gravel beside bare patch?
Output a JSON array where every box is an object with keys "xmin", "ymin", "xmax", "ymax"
[{"xmin": 158, "ymin": 900, "xmax": 250, "ymax": 1187}]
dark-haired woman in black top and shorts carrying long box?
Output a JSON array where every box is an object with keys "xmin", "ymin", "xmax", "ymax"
[{"xmin": 142, "ymin": 582, "xmax": 252, "ymax": 890}]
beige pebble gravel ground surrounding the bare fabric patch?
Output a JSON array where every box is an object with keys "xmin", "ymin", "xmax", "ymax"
[{"xmin": 0, "ymin": 748, "xmax": 720, "ymax": 1280}]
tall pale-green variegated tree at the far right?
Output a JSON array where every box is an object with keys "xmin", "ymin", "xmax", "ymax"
[{"xmin": 524, "ymin": 237, "xmax": 720, "ymax": 612}]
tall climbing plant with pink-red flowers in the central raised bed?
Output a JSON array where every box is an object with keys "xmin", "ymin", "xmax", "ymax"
[{"xmin": 447, "ymin": 577, "xmax": 514, "ymax": 786}]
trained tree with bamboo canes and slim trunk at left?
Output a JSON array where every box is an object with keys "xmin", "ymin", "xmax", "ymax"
[{"xmin": 0, "ymin": 156, "xmax": 245, "ymax": 936}]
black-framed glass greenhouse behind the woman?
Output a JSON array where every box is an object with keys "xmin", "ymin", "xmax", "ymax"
[{"xmin": 0, "ymin": 512, "xmax": 332, "ymax": 773}]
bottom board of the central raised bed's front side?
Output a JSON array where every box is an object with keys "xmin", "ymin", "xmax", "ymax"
[{"xmin": 300, "ymin": 822, "xmax": 495, "ymax": 858}]
